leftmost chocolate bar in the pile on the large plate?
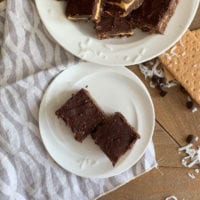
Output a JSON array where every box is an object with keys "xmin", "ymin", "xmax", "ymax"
[{"xmin": 66, "ymin": 0, "xmax": 103, "ymax": 21}]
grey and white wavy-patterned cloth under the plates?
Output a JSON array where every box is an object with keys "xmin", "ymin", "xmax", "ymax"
[{"xmin": 0, "ymin": 0, "xmax": 157, "ymax": 200}]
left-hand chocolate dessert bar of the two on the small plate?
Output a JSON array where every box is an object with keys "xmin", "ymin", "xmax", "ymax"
[{"xmin": 56, "ymin": 89, "xmax": 104, "ymax": 142}]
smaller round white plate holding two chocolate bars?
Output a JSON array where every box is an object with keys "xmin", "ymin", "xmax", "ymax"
[{"xmin": 39, "ymin": 63, "xmax": 155, "ymax": 178}]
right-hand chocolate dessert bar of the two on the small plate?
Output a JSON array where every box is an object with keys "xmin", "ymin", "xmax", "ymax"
[{"xmin": 92, "ymin": 112, "xmax": 140, "ymax": 166}]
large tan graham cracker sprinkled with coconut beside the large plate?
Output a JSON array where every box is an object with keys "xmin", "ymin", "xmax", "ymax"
[{"xmin": 159, "ymin": 31, "xmax": 200, "ymax": 104}]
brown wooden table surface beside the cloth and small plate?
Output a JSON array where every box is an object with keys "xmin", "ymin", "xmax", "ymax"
[{"xmin": 99, "ymin": 5, "xmax": 200, "ymax": 200}]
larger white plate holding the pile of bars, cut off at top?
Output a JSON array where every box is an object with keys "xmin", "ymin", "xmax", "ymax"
[{"xmin": 35, "ymin": 0, "xmax": 200, "ymax": 66}]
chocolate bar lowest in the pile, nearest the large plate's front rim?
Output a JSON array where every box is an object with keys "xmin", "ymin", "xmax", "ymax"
[{"xmin": 95, "ymin": 11, "xmax": 134, "ymax": 39}]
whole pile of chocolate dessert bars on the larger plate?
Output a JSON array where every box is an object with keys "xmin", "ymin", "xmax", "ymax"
[{"xmin": 66, "ymin": 0, "xmax": 179, "ymax": 39}]
